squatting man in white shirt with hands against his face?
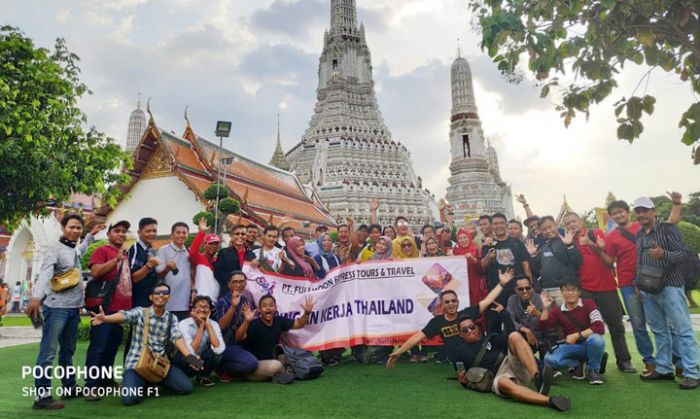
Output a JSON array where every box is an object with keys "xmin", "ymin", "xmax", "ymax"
[{"xmin": 173, "ymin": 295, "xmax": 226, "ymax": 387}]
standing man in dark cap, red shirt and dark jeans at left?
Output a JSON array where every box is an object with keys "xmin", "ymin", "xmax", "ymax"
[{"xmin": 85, "ymin": 220, "xmax": 132, "ymax": 401}]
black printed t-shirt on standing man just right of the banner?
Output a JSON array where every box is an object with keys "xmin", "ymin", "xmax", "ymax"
[{"xmin": 482, "ymin": 237, "xmax": 530, "ymax": 306}]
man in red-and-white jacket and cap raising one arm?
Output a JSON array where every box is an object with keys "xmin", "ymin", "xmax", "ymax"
[{"xmin": 190, "ymin": 217, "xmax": 221, "ymax": 301}]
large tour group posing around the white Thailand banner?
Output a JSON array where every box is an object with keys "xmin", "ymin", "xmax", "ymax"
[{"xmin": 27, "ymin": 194, "xmax": 700, "ymax": 411}]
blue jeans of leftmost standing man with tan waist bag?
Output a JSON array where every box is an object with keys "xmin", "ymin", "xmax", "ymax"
[{"xmin": 34, "ymin": 305, "xmax": 80, "ymax": 398}]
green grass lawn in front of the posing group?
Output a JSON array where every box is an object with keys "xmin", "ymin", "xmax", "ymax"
[{"xmin": 0, "ymin": 336, "xmax": 700, "ymax": 419}]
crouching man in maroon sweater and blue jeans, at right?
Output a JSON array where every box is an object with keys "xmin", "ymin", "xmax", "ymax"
[{"xmin": 539, "ymin": 277, "xmax": 608, "ymax": 384}]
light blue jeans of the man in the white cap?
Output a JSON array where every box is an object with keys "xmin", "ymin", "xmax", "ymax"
[{"xmin": 642, "ymin": 287, "xmax": 700, "ymax": 379}]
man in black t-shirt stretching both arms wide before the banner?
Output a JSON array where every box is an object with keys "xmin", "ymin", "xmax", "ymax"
[{"xmin": 386, "ymin": 270, "xmax": 513, "ymax": 368}]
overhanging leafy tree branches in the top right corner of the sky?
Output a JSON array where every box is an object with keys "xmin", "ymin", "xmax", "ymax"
[{"xmin": 469, "ymin": 0, "xmax": 700, "ymax": 164}]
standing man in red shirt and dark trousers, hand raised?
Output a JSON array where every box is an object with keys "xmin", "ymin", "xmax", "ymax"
[{"xmin": 564, "ymin": 212, "xmax": 637, "ymax": 373}]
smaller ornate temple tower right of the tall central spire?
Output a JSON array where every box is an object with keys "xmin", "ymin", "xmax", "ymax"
[{"xmin": 446, "ymin": 50, "xmax": 513, "ymax": 222}]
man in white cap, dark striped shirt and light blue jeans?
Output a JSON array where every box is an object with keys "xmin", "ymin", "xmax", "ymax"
[{"xmin": 632, "ymin": 197, "xmax": 700, "ymax": 390}]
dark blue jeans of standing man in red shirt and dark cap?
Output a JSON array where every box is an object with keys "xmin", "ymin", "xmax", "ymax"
[{"xmin": 85, "ymin": 323, "xmax": 124, "ymax": 388}]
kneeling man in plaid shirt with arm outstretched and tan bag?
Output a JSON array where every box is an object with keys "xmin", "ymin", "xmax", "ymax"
[{"xmin": 91, "ymin": 283, "xmax": 201, "ymax": 406}]
